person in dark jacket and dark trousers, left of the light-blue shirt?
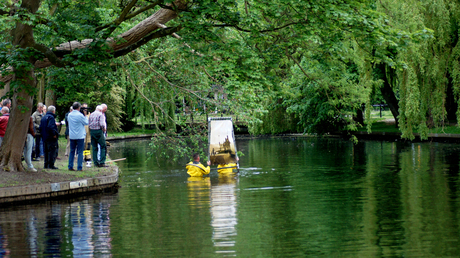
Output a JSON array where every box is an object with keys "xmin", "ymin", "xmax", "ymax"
[{"xmin": 40, "ymin": 106, "xmax": 59, "ymax": 169}]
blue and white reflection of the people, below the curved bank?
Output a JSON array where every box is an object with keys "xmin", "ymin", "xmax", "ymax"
[{"xmin": 0, "ymin": 197, "xmax": 111, "ymax": 257}]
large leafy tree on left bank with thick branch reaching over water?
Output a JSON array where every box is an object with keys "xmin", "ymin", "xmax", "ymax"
[{"xmin": 0, "ymin": 0, "xmax": 424, "ymax": 171}]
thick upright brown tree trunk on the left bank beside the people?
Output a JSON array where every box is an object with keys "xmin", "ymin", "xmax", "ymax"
[{"xmin": 0, "ymin": 0, "xmax": 40, "ymax": 171}]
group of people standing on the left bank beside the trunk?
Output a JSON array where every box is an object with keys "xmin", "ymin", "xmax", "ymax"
[{"xmin": 0, "ymin": 99, "xmax": 107, "ymax": 172}]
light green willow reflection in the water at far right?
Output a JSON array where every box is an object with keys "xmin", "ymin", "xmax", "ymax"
[{"xmin": 401, "ymin": 144, "xmax": 460, "ymax": 257}]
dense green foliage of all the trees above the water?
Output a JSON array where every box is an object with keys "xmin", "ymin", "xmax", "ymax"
[{"xmin": 0, "ymin": 0, "xmax": 460, "ymax": 166}]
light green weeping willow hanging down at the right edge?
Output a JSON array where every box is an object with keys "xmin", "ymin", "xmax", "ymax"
[{"xmin": 378, "ymin": 0, "xmax": 460, "ymax": 139}]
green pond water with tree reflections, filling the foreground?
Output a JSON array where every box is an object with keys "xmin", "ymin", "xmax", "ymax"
[{"xmin": 0, "ymin": 138, "xmax": 460, "ymax": 257}]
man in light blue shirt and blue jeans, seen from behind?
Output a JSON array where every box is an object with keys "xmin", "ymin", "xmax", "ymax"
[{"xmin": 67, "ymin": 102, "xmax": 88, "ymax": 171}]
